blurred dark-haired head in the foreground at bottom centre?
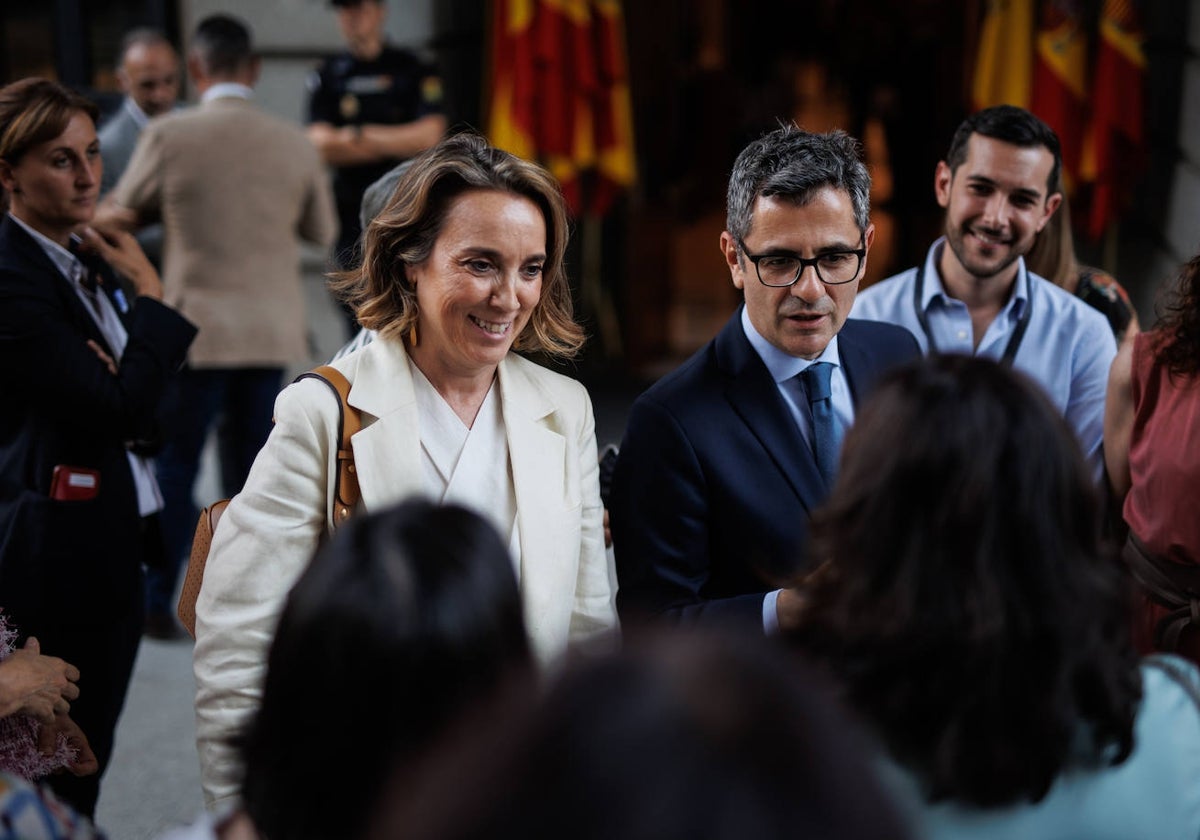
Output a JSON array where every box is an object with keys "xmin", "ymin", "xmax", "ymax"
[{"xmin": 371, "ymin": 628, "xmax": 910, "ymax": 840}]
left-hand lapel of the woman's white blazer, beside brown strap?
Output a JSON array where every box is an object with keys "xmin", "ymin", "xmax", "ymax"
[{"xmin": 347, "ymin": 340, "xmax": 422, "ymax": 511}]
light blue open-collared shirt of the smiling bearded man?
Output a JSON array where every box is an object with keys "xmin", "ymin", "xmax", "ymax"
[{"xmin": 851, "ymin": 238, "xmax": 1117, "ymax": 481}]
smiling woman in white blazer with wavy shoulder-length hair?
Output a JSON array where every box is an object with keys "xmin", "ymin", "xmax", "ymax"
[{"xmin": 194, "ymin": 132, "xmax": 617, "ymax": 806}]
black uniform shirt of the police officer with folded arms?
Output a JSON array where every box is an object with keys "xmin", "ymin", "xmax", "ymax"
[{"xmin": 308, "ymin": 47, "xmax": 442, "ymax": 266}]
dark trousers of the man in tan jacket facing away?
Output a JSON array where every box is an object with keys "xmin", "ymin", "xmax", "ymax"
[{"xmin": 146, "ymin": 367, "xmax": 283, "ymax": 616}]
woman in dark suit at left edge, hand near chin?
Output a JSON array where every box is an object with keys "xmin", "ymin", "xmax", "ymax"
[{"xmin": 0, "ymin": 78, "xmax": 196, "ymax": 816}]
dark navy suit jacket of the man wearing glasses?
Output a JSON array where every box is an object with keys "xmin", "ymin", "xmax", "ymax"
[{"xmin": 610, "ymin": 308, "xmax": 919, "ymax": 629}]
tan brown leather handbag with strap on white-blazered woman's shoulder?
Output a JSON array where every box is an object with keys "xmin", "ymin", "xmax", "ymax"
[{"xmin": 175, "ymin": 365, "xmax": 362, "ymax": 638}]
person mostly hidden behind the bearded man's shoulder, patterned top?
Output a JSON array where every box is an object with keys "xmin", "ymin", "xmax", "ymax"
[{"xmin": 1025, "ymin": 196, "xmax": 1139, "ymax": 347}]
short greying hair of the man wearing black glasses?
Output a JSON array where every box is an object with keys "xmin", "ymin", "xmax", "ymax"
[{"xmin": 725, "ymin": 125, "xmax": 871, "ymax": 240}]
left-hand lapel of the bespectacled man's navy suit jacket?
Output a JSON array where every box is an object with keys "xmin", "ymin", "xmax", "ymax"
[{"xmin": 716, "ymin": 307, "xmax": 826, "ymax": 510}]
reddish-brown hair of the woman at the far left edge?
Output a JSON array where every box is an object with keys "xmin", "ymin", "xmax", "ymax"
[{"xmin": 0, "ymin": 77, "xmax": 100, "ymax": 212}]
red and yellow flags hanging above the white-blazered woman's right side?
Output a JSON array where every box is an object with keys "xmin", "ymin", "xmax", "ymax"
[{"xmin": 487, "ymin": 0, "xmax": 636, "ymax": 215}]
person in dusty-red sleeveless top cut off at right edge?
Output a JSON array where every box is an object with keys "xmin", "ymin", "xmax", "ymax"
[{"xmin": 1104, "ymin": 247, "xmax": 1200, "ymax": 662}]
